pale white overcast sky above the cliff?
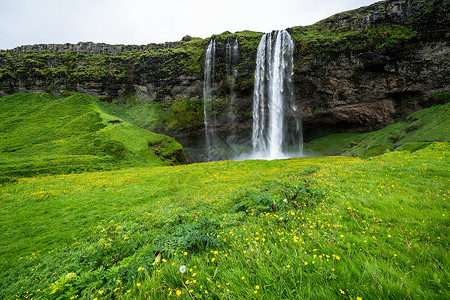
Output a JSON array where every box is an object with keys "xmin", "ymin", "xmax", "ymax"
[{"xmin": 0, "ymin": 0, "xmax": 377, "ymax": 49}]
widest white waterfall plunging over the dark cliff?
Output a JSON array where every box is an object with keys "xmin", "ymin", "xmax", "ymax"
[{"xmin": 252, "ymin": 30, "xmax": 303, "ymax": 159}]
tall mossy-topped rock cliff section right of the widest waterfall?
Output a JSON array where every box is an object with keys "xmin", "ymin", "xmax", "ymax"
[{"xmin": 291, "ymin": 0, "xmax": 450, "ymax": 136}]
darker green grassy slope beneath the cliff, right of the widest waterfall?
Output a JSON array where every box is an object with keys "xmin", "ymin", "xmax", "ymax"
[{"xmin": 305, "ymin": 100, "xmax": 450, "ymax": 158}]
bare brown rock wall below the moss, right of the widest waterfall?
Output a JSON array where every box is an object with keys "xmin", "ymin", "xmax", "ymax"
[{"xmin": 295, "ymin": 42, "xmax": 450, "ymax": 137}]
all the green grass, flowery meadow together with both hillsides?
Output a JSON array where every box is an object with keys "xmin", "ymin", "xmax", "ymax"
[{"xmin": 0, "ymin": 94, "xmax": 450, "ymax": 300}]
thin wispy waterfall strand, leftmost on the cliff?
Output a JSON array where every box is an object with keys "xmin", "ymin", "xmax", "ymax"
[{"xmin": 203, "ymin": 39, "xmax": 216, "ymax": 160}]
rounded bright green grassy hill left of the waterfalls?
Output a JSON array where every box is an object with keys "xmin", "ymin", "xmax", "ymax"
[{"xmin": 0, "ymin": 94, "xmax": 184, "ymax": 176}]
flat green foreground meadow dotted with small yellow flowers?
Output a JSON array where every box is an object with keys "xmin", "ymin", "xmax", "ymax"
[{"xmin": 0, "ymin": 143, "xmax": 450, "ymax": 299}]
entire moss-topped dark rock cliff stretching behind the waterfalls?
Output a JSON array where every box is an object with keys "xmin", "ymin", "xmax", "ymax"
[{"xmin": 0, "ymin": 0, "xmax": 450, "ymax": 143}]
